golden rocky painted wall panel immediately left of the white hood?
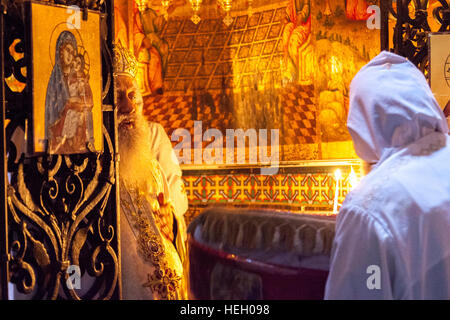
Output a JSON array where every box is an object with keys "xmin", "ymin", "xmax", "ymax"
[{"xmin": 312, "ymin": 0, "xmax": 379, "ymax": 142}]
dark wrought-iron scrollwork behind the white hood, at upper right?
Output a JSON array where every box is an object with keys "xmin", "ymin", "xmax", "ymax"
[{"xmin": 382, "ymin": 0, "xmax": 450, "ymax": 76}]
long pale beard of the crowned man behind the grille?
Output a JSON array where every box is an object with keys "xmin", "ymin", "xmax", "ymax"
[{"xmin": 118, "ymin": 114, "xmax": 154, "ymax": 187}]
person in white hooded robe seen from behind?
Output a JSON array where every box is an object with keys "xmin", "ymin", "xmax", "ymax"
[{"xmin": 325, "ymin": 52, "xmax": 450, "ymax": 299}]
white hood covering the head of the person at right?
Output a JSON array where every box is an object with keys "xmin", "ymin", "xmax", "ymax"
[{"xmin": 347, "ymin": 51, "xmax": 448, "ymax": 163}]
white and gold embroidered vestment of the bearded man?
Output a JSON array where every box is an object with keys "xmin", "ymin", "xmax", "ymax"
[{"xmin": 120, "ymin": 123, "xmax": 188, "ymax": 300}]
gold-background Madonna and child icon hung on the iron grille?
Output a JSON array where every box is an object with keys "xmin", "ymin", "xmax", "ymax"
[{"xmin": 26, "ymin": 2, "xmax": 103, "ymax": 155}]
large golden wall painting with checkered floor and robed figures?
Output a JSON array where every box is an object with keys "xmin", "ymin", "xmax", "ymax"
[{"xmin": 116, "ymin": 0, "xmax": 380, "ymax": 165}]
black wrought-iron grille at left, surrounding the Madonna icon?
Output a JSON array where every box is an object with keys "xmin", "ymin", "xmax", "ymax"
[{"xmin": 0, "ymin": 0, "xmax": 121, "ymax": 299}]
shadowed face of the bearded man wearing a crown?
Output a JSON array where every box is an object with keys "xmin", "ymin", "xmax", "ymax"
[{"xmin": 115, "ymin": 75, "xmax": 144, "ymax": 129}]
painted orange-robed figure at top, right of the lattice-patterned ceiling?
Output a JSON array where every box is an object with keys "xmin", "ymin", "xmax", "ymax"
[{"xmin": 282, "ymin": 0, "xmax": 311, "ymax": 80}]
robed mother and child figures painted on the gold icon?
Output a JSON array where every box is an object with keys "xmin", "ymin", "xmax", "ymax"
[{"xmin": 45, "ymin": 31, "xmax": 94, "ymax": 154}]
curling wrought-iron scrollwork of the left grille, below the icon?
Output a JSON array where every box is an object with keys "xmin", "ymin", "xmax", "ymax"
[{"xmin": 8, "ymin": 125, "xmax": 119, "ymax": 299}]
